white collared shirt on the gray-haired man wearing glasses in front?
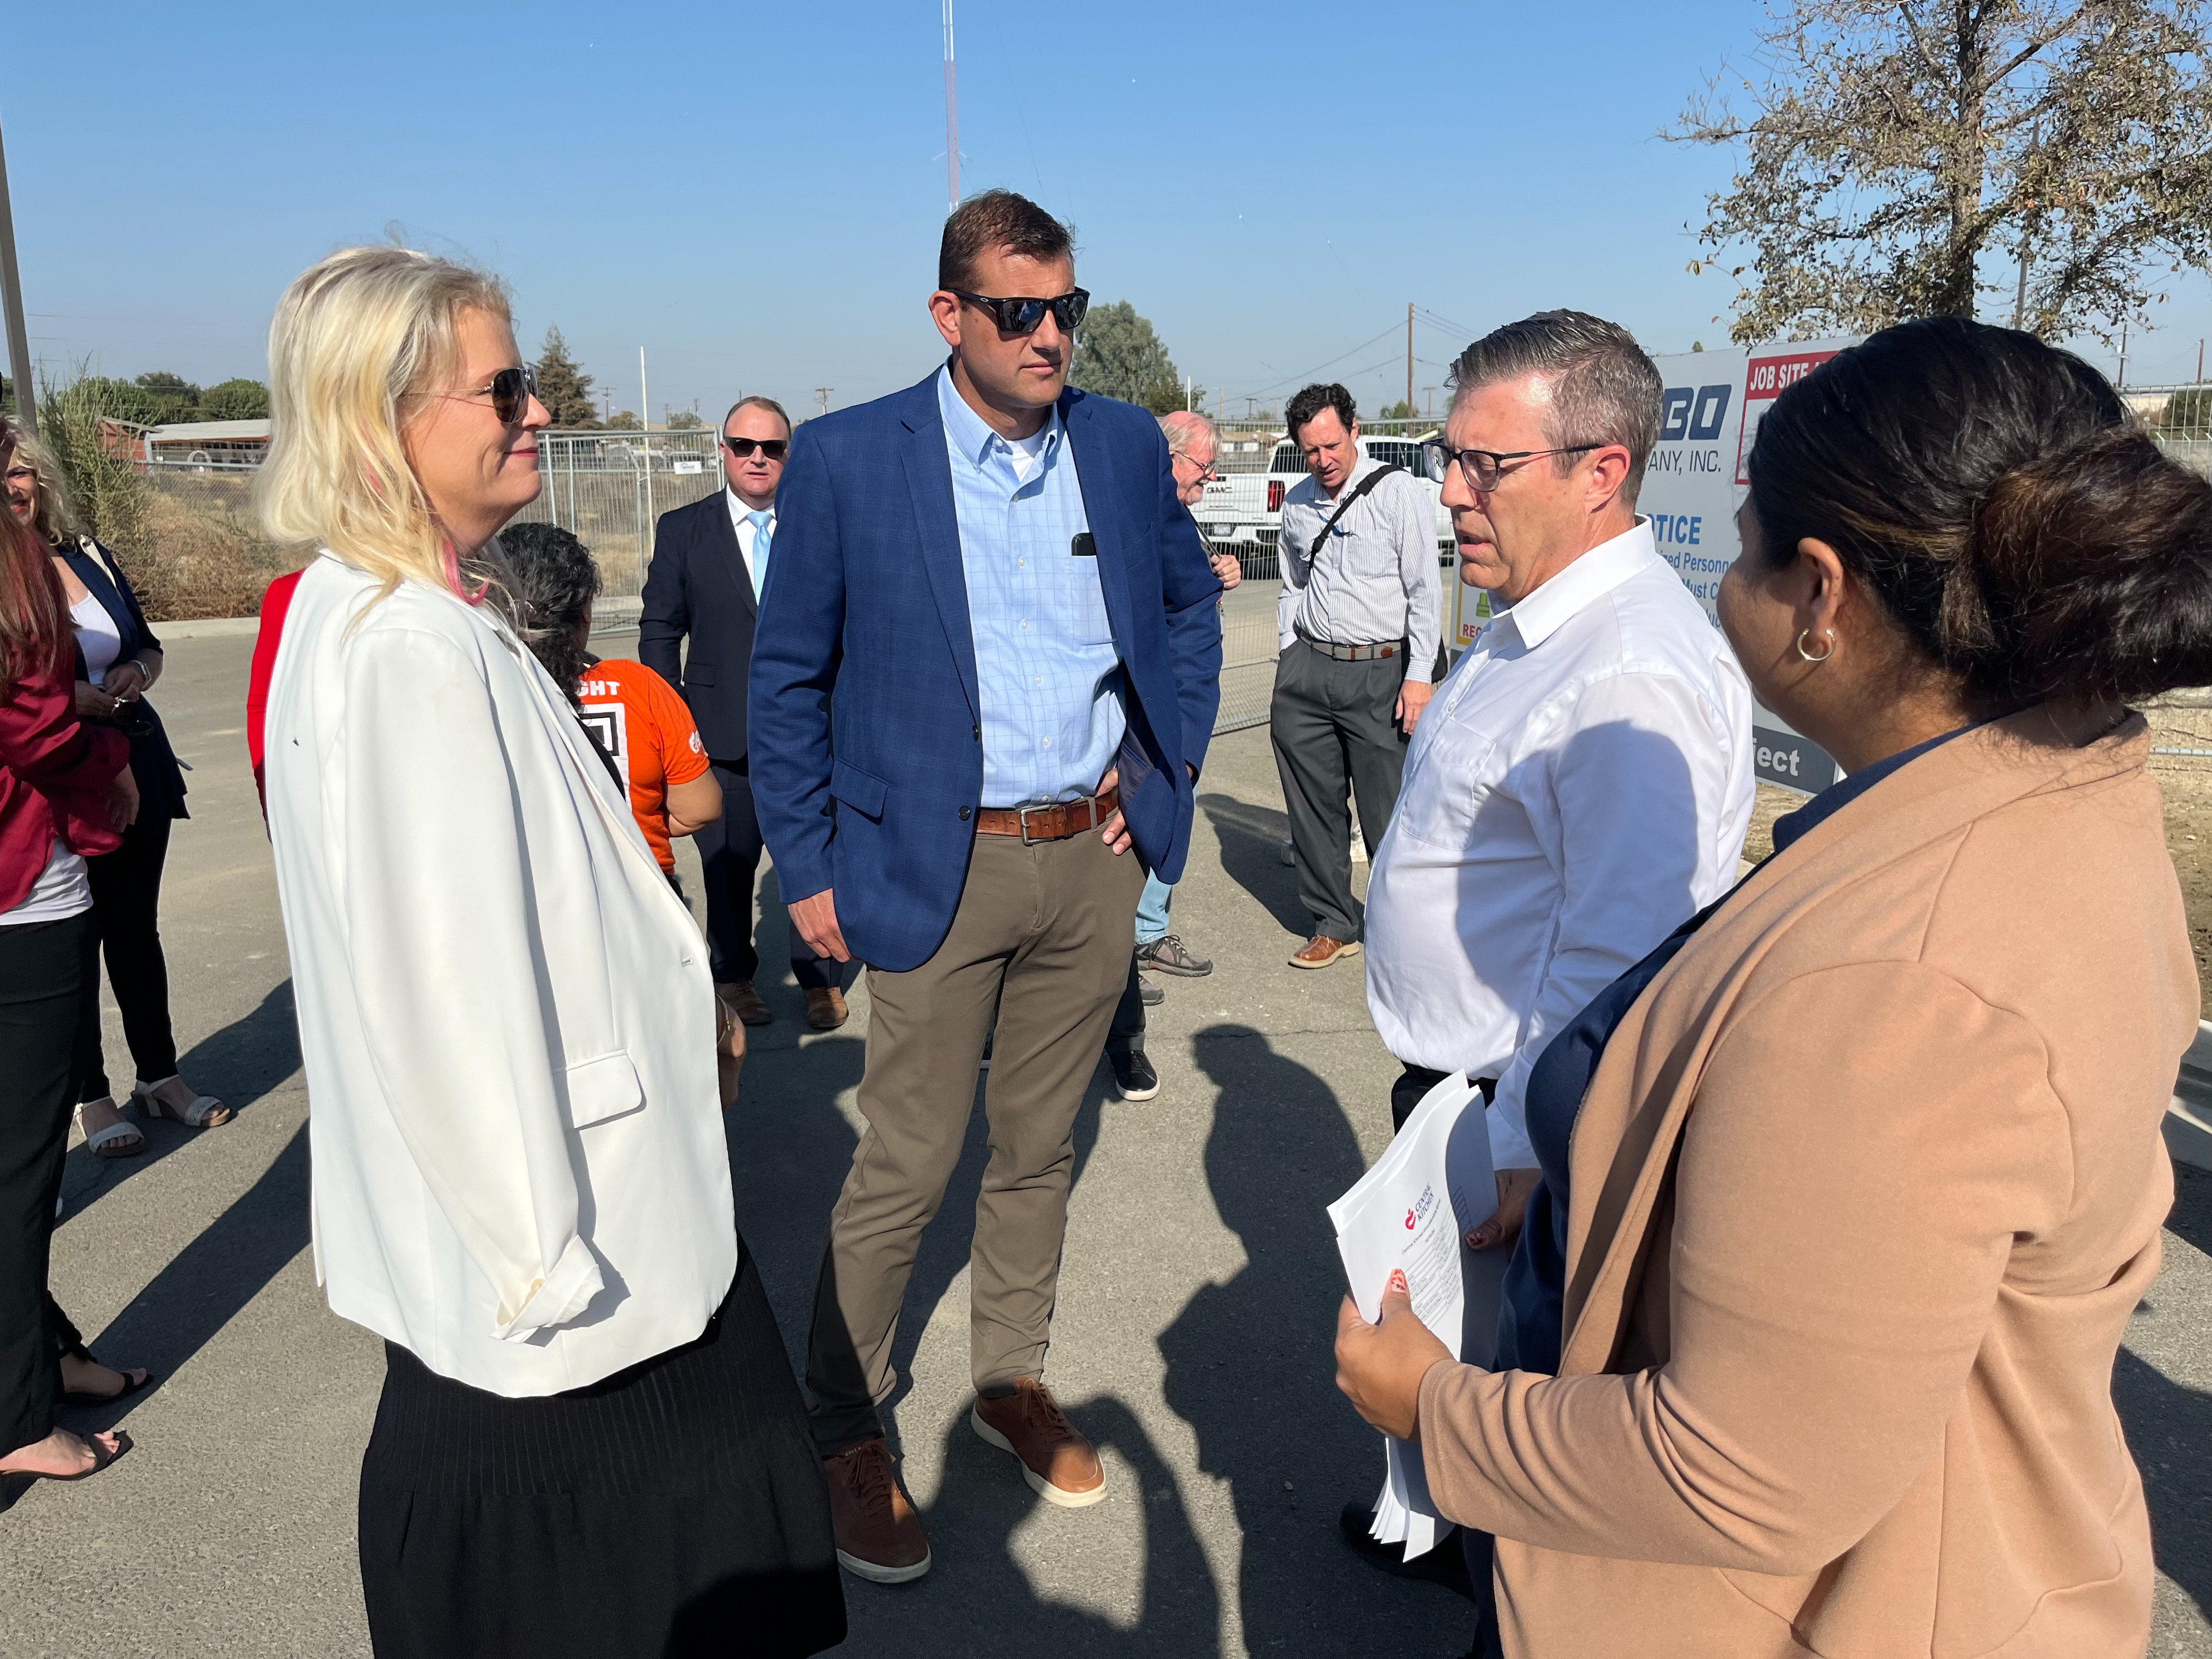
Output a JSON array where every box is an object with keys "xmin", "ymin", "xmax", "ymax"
[{"xmin": 1367, "ymin": 517, "xmax": 1754, "ymax": 1168}]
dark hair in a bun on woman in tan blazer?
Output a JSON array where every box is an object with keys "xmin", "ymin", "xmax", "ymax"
[{"xmin": 1750, "ymin": 317, "xmax": 2212, "ymax": 710}]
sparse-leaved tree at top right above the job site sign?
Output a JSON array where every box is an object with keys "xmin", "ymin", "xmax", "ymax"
[{"xmin": 1666, "ymin": 0, "xmax": 2212, "ymax": 343}]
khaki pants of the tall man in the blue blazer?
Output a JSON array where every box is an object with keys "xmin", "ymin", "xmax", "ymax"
[{"xmin": 808, "ymin": 832, "xmax": 1144, "ymax": 1453}]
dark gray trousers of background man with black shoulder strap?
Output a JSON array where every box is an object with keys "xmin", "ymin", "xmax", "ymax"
[{"xmin": 1267, "ymin": 639, "xmax": 1404, "ymax": 945}]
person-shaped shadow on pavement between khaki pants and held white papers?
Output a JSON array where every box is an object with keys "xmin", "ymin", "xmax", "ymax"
[{"xmin": 1159, "ymin": 1026, "xmax": 1449, "ymax": 1655}]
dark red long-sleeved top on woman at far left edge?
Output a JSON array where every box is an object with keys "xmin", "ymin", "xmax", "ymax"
[{"xmin": 0, "ymin": 641, "xmax": 131, "ymax": 911}]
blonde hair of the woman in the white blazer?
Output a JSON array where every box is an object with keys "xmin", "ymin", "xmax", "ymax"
[{"xmin": 255, "ymin": 248, "xmax": 513, "ymax": 604}]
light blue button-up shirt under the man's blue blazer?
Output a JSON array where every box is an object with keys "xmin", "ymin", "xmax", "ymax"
[{"xmin": 938, "ymin": 367, "xmax": 1128, "ymax": 808}]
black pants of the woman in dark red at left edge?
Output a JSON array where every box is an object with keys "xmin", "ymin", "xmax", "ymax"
[{"xmin": 0, "ymin": 911, "xmax": 99, "ymax": 1451}]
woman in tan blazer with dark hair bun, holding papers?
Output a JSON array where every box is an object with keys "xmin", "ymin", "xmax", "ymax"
[{"xmin": 1336, "ymin": 319, "xmax": 2212, "ymax": 1659}]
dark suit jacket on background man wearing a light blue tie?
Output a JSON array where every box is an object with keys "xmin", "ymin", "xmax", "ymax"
[{"xmin": 637, "ymin": 489, "xmax": 756, "ymax": 770}]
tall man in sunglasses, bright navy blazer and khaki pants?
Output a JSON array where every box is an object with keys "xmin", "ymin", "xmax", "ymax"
[{"xmin": 750, "ymin": 190, "xmax": 1221, "ymax": 1584}]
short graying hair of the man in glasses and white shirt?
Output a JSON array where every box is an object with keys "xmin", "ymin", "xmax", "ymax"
[{"xmin": 1451, "ymin": 312, "xmax": 1663, "ymax": 506}]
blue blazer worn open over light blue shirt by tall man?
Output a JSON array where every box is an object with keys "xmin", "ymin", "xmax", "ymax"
[{"xmin": 752, "ymin": 374, "xmax": 1221, "ymax": 971}]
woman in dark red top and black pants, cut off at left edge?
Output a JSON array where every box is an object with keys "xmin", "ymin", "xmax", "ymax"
[{"xmin": 0, "ymin": 420, "xmax": 146, "ymax": 1480}]
